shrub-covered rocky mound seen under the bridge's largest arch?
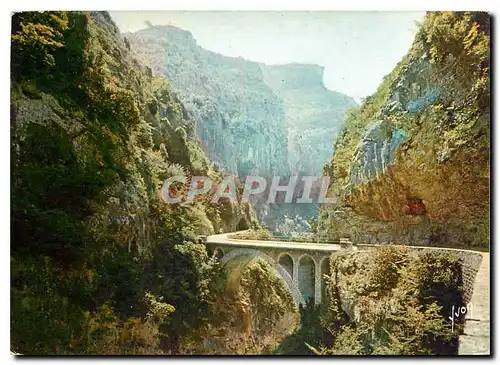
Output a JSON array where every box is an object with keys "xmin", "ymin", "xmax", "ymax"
[{"xmin": 189, "ymin": 255, "xmax": 299, "ymax": 355}]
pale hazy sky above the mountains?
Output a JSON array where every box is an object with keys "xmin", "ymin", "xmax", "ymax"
[{"xmin": 110, "ymin": 11, "xmax": 425, "ymax": 101}]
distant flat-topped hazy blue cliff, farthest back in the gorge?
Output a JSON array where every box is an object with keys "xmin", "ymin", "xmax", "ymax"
[{"xmin": 261, "ymin": 64, "xmax": 357, "ymax": 175}]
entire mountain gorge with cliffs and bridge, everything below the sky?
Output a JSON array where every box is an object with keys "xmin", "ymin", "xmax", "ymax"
[{"xmin": 10, "ymin": 11, "xmax": 491, "ymax": 355}]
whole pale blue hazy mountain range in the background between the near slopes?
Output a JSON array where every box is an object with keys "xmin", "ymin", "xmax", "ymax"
[{"xmin": 126, "ymin": 26, "xmax": 356, "ymax": 181}]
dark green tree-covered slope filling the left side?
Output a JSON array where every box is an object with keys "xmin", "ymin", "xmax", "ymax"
[{"xmin": 11, "ymin": 12, "xmax": 251, "ymax": 354}]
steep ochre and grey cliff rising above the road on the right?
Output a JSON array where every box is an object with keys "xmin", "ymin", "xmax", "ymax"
[{"xmin": 320, "ymin": 13, "xmax": 490, "ymax": 247}]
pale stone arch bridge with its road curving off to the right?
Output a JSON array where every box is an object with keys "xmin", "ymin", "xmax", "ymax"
[{"xmin": 206, "ymin": 232, "xmax": 490, "ymax": 355}]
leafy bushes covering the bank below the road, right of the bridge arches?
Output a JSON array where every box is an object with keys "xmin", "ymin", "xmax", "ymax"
[{"xmin": 296, "ymin": 246, "xmax": 464, "ymax": 355}]
